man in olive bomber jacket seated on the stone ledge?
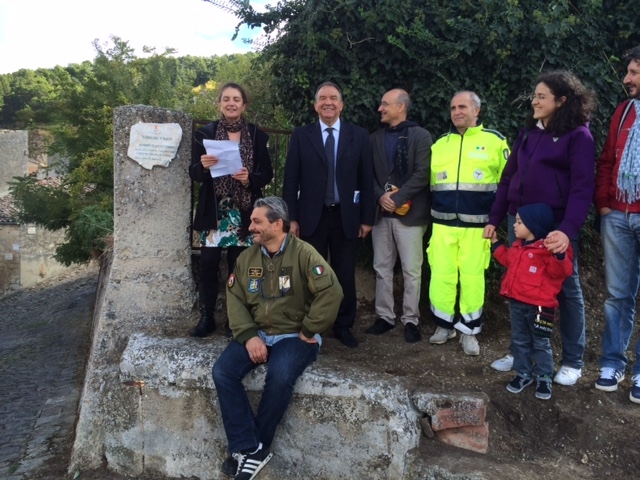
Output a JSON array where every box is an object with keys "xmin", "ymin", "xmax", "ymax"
[{"xmin": 213, "ymin": 197, "xmax": 343, "ymax": 480}]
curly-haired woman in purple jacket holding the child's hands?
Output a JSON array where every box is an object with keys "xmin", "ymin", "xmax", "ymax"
[{"xmin": 484, "ymin": 71, "xmax": 595, "ymax": 385}]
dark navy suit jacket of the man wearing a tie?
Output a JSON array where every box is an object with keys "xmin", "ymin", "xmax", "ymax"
[{"xmin": 282, "ymin": 121, "xmax": 375, "ymax": 239}]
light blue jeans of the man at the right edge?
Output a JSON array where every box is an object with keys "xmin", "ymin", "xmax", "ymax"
[{"xmin": 600, "ymin": 210, "xmax": 640, "ymax": 375}]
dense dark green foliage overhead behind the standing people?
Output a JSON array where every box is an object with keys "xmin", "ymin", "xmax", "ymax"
[{"xmin": 208, "ymin": 0, "xmax": 640, "ymax": 148}]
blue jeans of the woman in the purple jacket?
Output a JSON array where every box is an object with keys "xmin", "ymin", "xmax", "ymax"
[{"xmin": 508, "ymin": 215, "xmax": 587, "ymax": 368}]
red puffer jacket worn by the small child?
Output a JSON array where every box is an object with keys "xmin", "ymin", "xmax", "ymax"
[{"xmin": 493, "ymin": 239, "xmax": 573, "ymax": 308}]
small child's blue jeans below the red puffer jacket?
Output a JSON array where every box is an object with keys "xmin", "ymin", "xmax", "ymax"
[{"xmin": 509, "ymin": 299, "xmax": 553, "ymax": 377}]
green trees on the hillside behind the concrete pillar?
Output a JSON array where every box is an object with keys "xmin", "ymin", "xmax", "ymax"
[{"xmin": 0, "ymin": 36, "xmax": 278, "ymax": 265}]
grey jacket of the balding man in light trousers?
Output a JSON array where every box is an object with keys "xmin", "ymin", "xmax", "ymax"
[{"xmin": 370, "ymin": 127, "xmax": 433, "ymax": 227}]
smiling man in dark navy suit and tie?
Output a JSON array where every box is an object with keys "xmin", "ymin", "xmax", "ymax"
[{"xmin": 282, "ymin": 82, "xmax": 375, "ymax": 347}]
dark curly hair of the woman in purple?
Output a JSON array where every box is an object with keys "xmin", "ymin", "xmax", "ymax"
[{"xmin": 527, "ymin": 70, "xmax": 596, "ymax": 135}]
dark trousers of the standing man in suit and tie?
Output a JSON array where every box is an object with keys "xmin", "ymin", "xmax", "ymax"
[{"xmin": 300, "ymin": 206, "xmax": 358, "ymax": 330}]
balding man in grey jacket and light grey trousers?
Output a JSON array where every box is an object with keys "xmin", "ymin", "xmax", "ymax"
[{"xmin": 366, "ymin": 89, "xmax": 432, "ymax": 343}]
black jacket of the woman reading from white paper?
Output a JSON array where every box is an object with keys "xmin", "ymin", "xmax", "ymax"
[{"xmin": 189, "ymin": 121, "xmax": 273, "ymax": 231}]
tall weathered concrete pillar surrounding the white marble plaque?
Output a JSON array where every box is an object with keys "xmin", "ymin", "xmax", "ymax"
[{"xmin": 72, "ymin": 106, "xmax": 194, "ymax": 468}]
